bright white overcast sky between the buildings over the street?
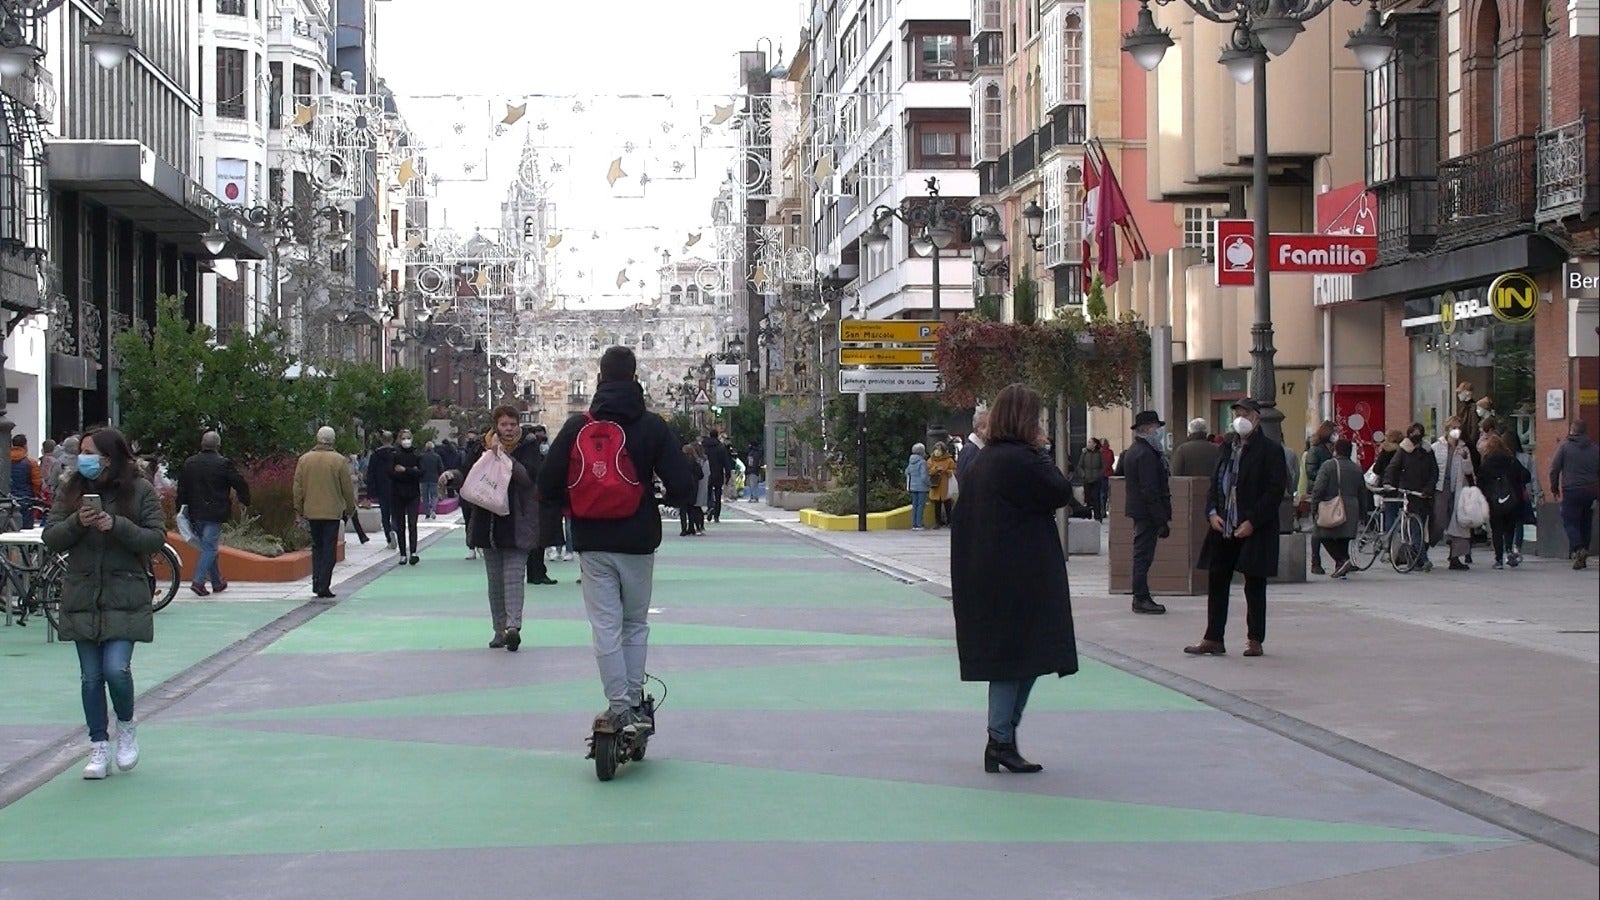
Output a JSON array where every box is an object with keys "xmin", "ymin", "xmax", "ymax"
[{"xmin": 378, "ymin": 0, "xmax": 805, "ymax": 267}]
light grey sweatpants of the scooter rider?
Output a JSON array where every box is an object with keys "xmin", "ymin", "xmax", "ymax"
[{"xmin": 579, "ymin": 551, "xmax": 656, "ymax": 713}]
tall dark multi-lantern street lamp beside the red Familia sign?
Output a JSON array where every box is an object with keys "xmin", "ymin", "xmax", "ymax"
[{"xmin": 1122, "ymin": 0, "xmax": 1395, "ymax": 442}]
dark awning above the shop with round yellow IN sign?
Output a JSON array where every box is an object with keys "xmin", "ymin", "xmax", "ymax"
[{"xmin": 1350, "ymin": 234, "xmax": 1566, "ymax": 299}]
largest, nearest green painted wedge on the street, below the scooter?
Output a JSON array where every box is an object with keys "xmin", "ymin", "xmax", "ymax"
[{"xmin": 0, "ymin": 724, "xmax": 1504, "ymax": 862}]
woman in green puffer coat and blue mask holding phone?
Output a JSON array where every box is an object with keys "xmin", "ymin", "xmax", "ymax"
[{"xmin": 43, "ymin": 428, "xmax": 166, "ymax": 778}]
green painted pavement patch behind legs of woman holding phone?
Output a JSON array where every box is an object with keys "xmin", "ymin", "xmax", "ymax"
[{"xmin": 0, "ymin": 601, "xmax": 301, "ymax": 725}]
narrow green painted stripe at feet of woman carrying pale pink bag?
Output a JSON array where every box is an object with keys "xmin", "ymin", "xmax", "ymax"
[{"xmin": 264, "ymin": 602, "xmax": 952, "ymax": 653}]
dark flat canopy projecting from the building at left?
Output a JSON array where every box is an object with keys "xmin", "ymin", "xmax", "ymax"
[{"xmin": 46, "ymin": 141, "xmax": 267, "ymax": 259}]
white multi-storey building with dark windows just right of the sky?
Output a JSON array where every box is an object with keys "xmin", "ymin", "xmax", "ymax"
[{"xmin": 811, "ymin": 0, "xmax": 978, "ymax": 319}]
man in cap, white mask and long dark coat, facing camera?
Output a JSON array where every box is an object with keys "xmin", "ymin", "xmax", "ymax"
[{"xmin": 1184, "ymin": 399, "xmax": 1288, "ymax": 657}]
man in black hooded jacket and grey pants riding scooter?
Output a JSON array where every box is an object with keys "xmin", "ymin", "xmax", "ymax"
[{"xmin": 539, "ymin": 348, "xmax": 694, "ymax": 733}]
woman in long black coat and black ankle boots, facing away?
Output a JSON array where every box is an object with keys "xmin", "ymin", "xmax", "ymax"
[{"xmin": 950, "ymin": 384, "xmax": 1078, "ymax": 772}]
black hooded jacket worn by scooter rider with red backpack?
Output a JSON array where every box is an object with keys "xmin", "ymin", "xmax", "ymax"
[{"xmin": 539, "ymin": 373, "xmax": 694, "ymax": 554}]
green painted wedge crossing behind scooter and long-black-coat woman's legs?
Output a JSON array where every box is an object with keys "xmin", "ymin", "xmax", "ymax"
[{"xmin": 221, "ymin": 653, "xmax": 1210, "ymax": 721}]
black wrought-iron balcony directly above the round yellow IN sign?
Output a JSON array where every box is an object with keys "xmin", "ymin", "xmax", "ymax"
[{"xmin": 1438, "ymin": 135, "xmax": 1538, "ymax": 250}]
